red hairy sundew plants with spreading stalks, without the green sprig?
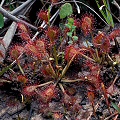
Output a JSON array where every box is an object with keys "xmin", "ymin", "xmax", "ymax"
[{"xmin": 1, "ymin": 8, "xmax": 120, "ymax": 120}]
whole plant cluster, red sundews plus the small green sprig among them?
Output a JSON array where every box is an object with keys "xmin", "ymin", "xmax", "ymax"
[{"xmin": 0, "ymin": 0, "xmax": 120, "ymax": 120}]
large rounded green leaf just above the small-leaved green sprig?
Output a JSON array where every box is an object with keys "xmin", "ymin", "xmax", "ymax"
[{"xmin": 60, "ymin": 3, "xmax": 73, "ymax": 19}]
